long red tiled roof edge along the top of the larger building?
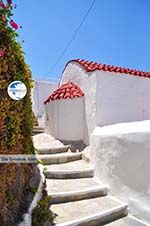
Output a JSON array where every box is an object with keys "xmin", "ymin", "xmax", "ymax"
[{"xmin": 66, "ymin": 59, "xmax": 150, "ymax": 78}]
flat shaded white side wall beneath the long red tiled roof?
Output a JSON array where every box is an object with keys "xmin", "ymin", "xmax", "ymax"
[{"xmin": 96, "ymin": 71, "xmax": 150, "ymax": 126}]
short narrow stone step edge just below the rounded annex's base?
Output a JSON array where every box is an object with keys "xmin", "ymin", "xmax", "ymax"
[{"xmin": 36, "ymin": 145, "xmax": 71, "ymax": 155}]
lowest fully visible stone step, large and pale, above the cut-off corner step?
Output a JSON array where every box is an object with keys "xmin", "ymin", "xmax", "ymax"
[{"xmin": 51, "ymin": 196, "xmax": 127, "ymax": 226}]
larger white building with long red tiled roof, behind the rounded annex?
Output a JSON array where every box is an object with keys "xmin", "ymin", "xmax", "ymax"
[{"xmin": 61, "ymin": 60, "xmax": 150, "ymax": 142}]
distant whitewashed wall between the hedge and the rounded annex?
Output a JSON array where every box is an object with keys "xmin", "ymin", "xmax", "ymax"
[{"xmin": 31, "ymin": 81, "xmax": 58, "ymax": 117}]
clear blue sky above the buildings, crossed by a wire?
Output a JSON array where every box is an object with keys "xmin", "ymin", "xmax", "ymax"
[{"xmin": 14, "ymin": 0, "xmax": 150, "ymax": 80}]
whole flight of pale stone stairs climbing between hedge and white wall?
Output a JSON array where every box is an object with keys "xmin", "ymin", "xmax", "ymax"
[{"xmin": 36, "ymin": 134, "xmax": 146, "ymax": 226}]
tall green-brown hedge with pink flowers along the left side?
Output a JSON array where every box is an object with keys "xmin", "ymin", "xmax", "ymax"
[{"xmin": 0, "ymin": 0, "xmax": 34, "ymax": 226}]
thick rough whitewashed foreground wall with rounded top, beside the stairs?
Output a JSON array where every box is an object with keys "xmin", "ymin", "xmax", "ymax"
[{"xmin": 90, "ymin": 121, "xmax": 150, "ymax": 224}]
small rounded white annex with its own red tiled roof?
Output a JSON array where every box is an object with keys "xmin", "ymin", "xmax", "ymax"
[{"xmin": 44, "ymin": 82, "xmax": 86, "ymax": 141}]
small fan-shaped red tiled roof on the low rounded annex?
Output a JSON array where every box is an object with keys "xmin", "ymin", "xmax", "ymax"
[{"xmin": 44, "ymin": 81, "xmax": 84, "ymax": 104}]
